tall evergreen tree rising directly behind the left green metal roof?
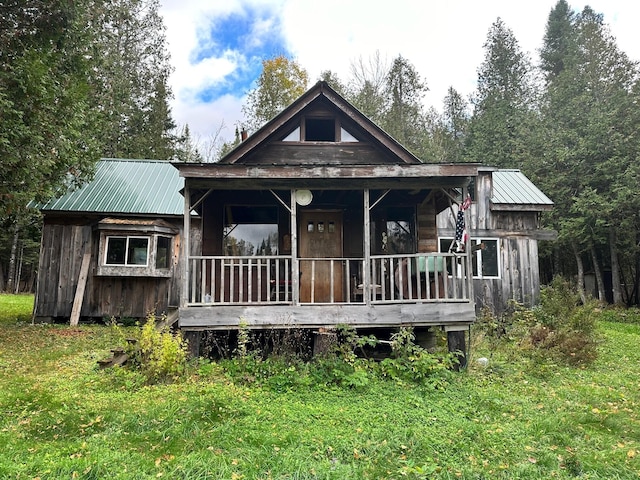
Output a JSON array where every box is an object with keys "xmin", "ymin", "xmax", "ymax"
[{"xmin": 87, "ymin": 0, "xmax": 176, "ymax": 159}]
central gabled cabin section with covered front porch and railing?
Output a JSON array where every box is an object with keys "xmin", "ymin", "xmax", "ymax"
[{"xmin": 174, "ymin": 82, "xmax": 479, "ymax": 358}]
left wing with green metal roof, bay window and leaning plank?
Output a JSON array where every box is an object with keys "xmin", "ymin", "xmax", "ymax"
[{"xmin": 34, "ymin": 159, "xmax": 198, "ymax": 323}]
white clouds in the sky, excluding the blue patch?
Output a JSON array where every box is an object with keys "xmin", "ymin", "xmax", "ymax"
[{"xmin": 161, "ymin": 0, "xmax": 640, "ymax": 144}]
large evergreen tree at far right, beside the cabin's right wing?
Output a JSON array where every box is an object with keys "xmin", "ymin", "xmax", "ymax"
[{"xmin": 537, "ymin": 3, "xmax": 640, "ymax": 303}]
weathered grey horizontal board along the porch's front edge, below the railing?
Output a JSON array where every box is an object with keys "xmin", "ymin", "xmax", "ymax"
[{"xmin": 179, "ymin": 301, "xmax": 475, "ymax": 330}]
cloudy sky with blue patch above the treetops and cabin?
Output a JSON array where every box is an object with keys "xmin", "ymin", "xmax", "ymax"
[{"xmin": 160, "ymin": 0, "xmax": 640, "ymax": 143}]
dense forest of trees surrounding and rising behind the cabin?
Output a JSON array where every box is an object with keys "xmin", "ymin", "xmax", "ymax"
[{"xmin": 0, "ymin": 0, "xmax": 640, "ymax": 305}]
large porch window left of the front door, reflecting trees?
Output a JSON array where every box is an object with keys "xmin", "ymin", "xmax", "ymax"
[{"xmin": 223, "ymin": 205, "xmax": 278, "ymax": 256}]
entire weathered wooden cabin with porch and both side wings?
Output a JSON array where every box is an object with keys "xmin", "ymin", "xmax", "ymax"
[{"xmin": 34, "ymin": 82, "xmax": 550, "ymax": 360}]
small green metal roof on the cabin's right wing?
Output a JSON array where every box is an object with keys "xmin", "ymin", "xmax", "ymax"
[{"xmin": 491, "ymin": 169, "xmax": 553, "ymax": 207}]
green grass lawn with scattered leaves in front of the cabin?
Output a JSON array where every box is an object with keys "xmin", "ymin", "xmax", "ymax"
[{"xmin": 0, "ymin": 296, "xmax": 640, "ymax": 480}]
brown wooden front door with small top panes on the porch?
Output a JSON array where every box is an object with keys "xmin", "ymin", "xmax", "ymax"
[{"xmin": 299, "ymin": 210, "xmax": 344, "ymax": 303}]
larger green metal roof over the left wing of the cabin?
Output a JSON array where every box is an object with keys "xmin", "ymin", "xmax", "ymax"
[{"xmin": 41, "ymin": 158, "xmax": 184, "ymax": 215}]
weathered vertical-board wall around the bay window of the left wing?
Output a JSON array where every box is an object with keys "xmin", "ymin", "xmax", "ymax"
[{"xmin": 34, "ymin": 220, "xmax": 200, "ymax": 320}]
